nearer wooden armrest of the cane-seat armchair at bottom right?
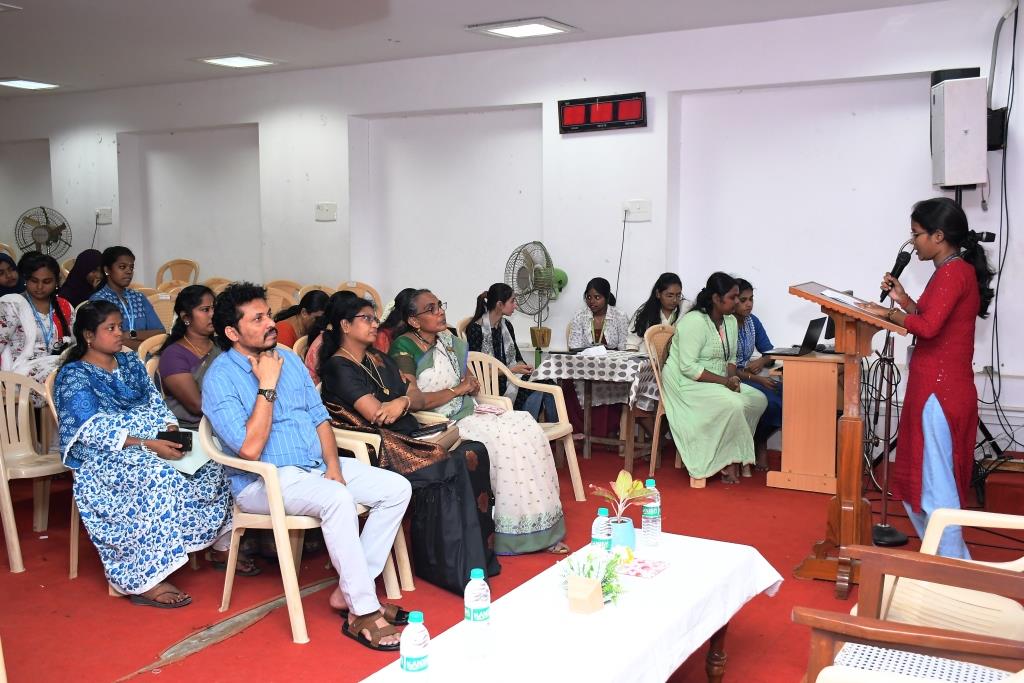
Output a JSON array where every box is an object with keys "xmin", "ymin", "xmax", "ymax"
[{"xmin": 793, "ymin": 607, "xmax": 1024, "ymax": 668}]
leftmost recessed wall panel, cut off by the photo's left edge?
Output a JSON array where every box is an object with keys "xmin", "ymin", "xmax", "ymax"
[{"xmin": 0, "ymin": 139, "xmax": 52, "ymax": 240}]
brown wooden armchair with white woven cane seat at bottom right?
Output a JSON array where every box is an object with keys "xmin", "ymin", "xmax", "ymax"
[{"xmin": 793, "ymin": 546, "xmax": 1024, "ymax": 683}]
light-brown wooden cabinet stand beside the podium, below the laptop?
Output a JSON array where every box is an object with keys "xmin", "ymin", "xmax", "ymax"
[{"xmin": 768, "ymin": 352, "xmax": 844, "ymax": 494}]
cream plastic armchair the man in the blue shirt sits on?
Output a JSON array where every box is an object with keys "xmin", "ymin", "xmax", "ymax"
[{"xmin": 199, "ymin": 417, "xmax": 412, "ymax": 644}]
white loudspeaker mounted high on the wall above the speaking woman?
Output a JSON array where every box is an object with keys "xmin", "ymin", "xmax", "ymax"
[{"xmin": 932, "ymin": 78, "xmax": 988, "ymax": 187}]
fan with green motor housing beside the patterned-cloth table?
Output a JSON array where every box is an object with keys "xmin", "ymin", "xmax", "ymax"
[{"xmin": 505, "ymin": 242, "xmax": 568, "ymax": 364}]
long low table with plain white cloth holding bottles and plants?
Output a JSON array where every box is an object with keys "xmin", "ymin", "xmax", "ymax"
[{"xmin": 366, "ymin": 533, "xmax": 782, "ymax": 683}]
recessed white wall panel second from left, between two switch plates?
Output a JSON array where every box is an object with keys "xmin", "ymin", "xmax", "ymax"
[{"xmin": 118, "ymin": 125, "xmax": 263, "ymax": 286}]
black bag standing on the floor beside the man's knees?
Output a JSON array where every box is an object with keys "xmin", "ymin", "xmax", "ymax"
[{"xmin": 406, "ymin": 453, "xmax": 501, "ymax": 595}]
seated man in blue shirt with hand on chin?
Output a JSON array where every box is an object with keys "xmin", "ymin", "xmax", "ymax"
[{"xmin": 203, "ymin": 283, "xmax": 411, "ymax": 650}]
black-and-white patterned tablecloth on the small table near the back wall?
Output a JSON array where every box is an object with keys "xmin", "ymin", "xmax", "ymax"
[{"xmin": 530, "ymin": 351, "xmax": 660, "ymax": 411}]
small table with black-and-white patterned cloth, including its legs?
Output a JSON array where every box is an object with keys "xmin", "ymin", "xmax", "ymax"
[{"xmin": 530, "ymin": 351, "xmax": 662, "ymax": 471}]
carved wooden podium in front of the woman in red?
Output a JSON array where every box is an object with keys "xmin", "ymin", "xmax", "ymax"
[{"xmin": 790, "ymin": 283, "xmax": 906, "ymax": 599}]
